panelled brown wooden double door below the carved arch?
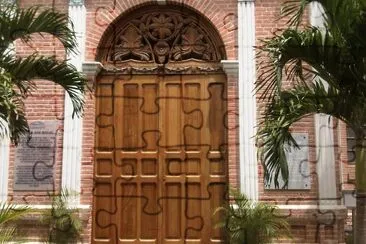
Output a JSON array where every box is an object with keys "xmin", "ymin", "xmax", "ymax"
[{"xmin": 92, "ymin": 74, "xmax": 227, "ymax": 243}]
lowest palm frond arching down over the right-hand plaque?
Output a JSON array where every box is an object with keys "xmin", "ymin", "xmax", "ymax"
[{"xmin": 257, "ymin": 81, "xmax": 350, "ymax": 188}]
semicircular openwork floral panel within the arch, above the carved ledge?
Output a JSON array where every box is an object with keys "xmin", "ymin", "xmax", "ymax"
[{"xmin": 104, "ymin": 12, "xmax": 221, "ymax": 64}]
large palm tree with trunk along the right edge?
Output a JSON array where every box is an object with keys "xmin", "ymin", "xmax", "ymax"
[{"xmin": 257, "ymin": 0, "xmax": 366, "ymax": 243}]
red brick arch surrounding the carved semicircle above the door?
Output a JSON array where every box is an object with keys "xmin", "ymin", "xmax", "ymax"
[{"xmin": 86, "ymin": 0, "xmax": 237, "ymax": 60}]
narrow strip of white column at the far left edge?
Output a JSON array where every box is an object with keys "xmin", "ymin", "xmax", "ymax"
[{"xmin": 0, "ymin": 138, "xmax": 9, "ymax": 202}]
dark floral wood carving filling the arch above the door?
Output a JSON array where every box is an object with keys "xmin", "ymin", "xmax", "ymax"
[{"xmin": 100, "ymin": 7, "xmax": 224, "ymax": 70}]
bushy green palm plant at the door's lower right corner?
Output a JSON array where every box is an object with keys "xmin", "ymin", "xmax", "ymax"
[{"xmin": 214, "ymin": 190, "xmax": 290, "ymax": 244}]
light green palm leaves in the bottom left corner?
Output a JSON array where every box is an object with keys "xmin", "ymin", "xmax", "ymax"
[{"xmin": 0, "ymin": 202, "xmax": 31, "ymax": 243}]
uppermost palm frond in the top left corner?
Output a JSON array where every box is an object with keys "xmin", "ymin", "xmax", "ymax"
[{"xmin": 0, "ymin": 3, "xmax": 77, "ymax": 52}]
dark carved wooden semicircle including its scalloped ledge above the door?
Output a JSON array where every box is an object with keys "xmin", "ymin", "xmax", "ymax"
[{"xmin": 98, "ymin": 6, "xmax": 225, "ymax": 73}]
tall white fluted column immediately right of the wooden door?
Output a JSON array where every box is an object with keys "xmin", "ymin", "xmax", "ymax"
[{"xmin": 238, "ymin": 0, "xmax": 258, "ymax": 200}]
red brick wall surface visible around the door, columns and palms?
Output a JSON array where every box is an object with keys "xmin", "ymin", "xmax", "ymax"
[{"xmin": 9, "ymin": 0, "xmax": 354, "ymax": 243}]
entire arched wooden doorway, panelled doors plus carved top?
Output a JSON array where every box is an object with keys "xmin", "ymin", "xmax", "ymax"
[{"xmin": 92, "ymin": 5, "xmax": 227, "ymax": 243}]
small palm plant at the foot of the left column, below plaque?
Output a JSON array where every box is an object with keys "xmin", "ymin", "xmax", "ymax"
[{"xmin": 42, "ymin": 189, "xmax": 82, "ymax": 244}]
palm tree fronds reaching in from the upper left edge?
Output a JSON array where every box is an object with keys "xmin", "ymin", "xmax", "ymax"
[{"xmin": 0, "ymin": 0, "xmax": 86, "ymax": 144}]
